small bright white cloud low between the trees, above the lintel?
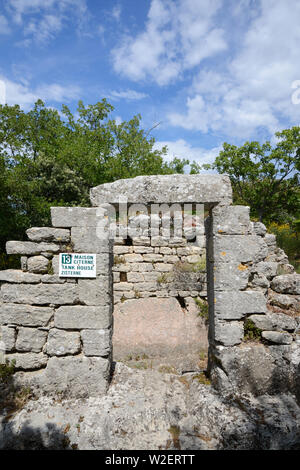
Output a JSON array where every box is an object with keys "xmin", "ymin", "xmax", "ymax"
[{"xmin": 154, "ymin": 139, "xmax": 222, "ymax": 164}]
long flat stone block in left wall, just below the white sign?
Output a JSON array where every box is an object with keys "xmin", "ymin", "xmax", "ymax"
[{"xmin": 1, "ymin": 283, "xmax": 78, "ymax": 305}]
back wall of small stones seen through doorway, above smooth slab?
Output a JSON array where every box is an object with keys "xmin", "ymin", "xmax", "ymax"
[{"xmin": 113, "ymin": 214, "xmax": 207, "ymax": 304}]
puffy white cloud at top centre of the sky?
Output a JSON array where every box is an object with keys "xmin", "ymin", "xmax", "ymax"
[{"xmin": 112, "ymin": 0, "xmax": 226, "ymax": 85}]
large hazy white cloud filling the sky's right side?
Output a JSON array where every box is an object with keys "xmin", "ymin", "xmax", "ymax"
[{"xmin": 169, "ymin": 0, "xmax": 300, "ymax": 138}]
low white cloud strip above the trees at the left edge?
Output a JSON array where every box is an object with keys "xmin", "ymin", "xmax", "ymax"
[{"xmin": 0, "ymin": 76, "xmax": 80, "ymax": 110}]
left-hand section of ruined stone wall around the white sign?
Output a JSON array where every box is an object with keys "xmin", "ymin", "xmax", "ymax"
[{"xmin": 0, "ymin": 207, "xmax": 112, "ymax": 396}]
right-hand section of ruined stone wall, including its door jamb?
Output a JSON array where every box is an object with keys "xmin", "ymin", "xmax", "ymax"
[{"xmin": 207, "ymin": 206, "xmax": 300, "ymax": 398}]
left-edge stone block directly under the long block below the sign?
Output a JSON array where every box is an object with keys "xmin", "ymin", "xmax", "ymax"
[{"xmin": 0, "ymin": 303, "xmax": 54, "ymax": 327}]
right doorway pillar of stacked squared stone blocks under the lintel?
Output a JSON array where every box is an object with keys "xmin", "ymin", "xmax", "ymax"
[{"xmin": 207, "ymin": 205, "xmax": 267, "ymax": 387}]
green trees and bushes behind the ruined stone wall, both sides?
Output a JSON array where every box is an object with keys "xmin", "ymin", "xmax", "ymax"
[{"xmin": 0, "ymin": 95, "xmax": 300, "ymax": 272}]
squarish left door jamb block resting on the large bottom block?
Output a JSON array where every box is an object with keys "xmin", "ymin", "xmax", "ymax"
[{"xmin": 81, "ymin": 329, "xmax": 112, "ymax": 357}]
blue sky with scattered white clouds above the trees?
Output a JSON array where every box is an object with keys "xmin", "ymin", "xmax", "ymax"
[{"xmin": 0, "ymin": 0, "xmax": 300, "ymax": 163}]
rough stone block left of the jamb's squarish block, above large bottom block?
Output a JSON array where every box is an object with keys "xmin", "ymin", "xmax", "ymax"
[{"xmin": 46, "ymin": 328, "xmax": 81, "ymax": 356}]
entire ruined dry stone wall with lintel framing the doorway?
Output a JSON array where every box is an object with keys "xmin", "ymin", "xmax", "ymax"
[{"xmin": 0, "ymin": 175, "xmax": 300, "ymax": 400}]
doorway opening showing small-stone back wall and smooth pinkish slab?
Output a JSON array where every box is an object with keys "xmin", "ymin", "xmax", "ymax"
[{"xmin": 113, "ymin": 209, "xmax": 208, "ymax": 373}]
